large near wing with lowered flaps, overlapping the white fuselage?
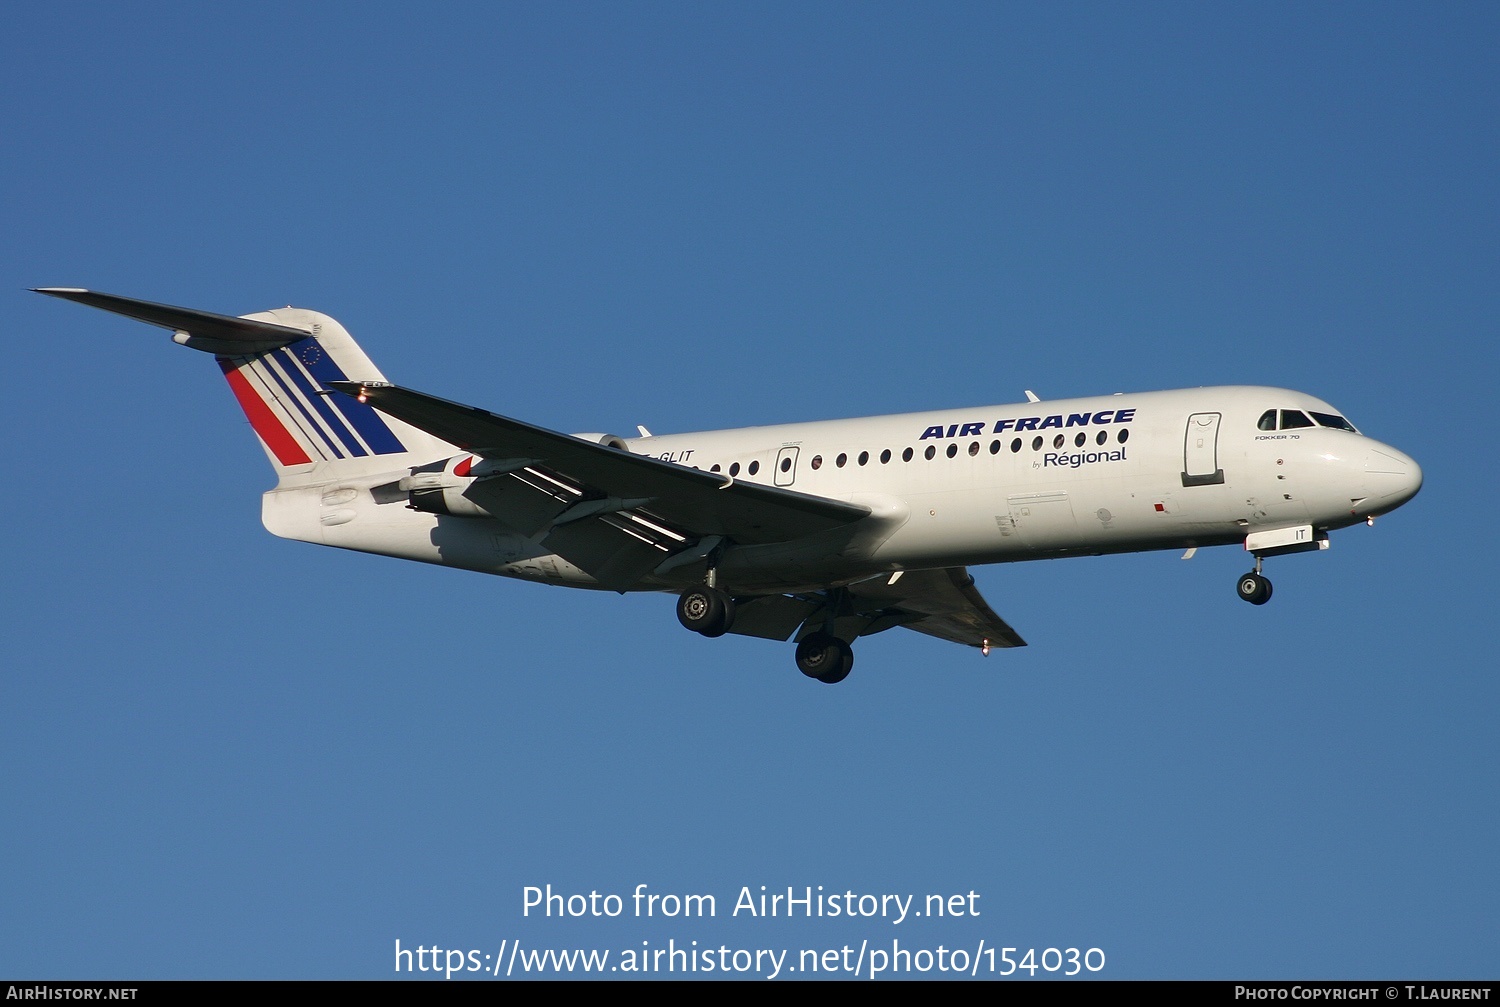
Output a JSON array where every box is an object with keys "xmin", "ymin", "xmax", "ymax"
[{"xmin": 329, "ymin": 381, "xmax": 870, "ymax": 591}]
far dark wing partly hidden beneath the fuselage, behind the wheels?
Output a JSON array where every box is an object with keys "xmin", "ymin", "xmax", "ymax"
[{"xmin": 729, "ymin": 566, "xmax": 1026, "ymax": 647}]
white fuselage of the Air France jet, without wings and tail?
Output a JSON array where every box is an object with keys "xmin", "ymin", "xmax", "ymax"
[{"xmin": 264, "ymin": 387, "xmax": 1422, "ymax": 593}]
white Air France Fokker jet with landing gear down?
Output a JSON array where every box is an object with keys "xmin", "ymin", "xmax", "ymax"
[{"xmin": 35, "ymin": 287, "xmax": 1422, "ymax": 684}]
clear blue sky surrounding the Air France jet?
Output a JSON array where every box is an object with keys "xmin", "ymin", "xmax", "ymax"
[{"xmin": 0, "ymin": 3, "xmax": 1500, "ymax": 978}]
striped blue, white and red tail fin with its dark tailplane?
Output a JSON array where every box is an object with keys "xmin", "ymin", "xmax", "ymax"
[{"xmin": 38, "ymin": 287, "xmax": 458, "ymax": 483}]
